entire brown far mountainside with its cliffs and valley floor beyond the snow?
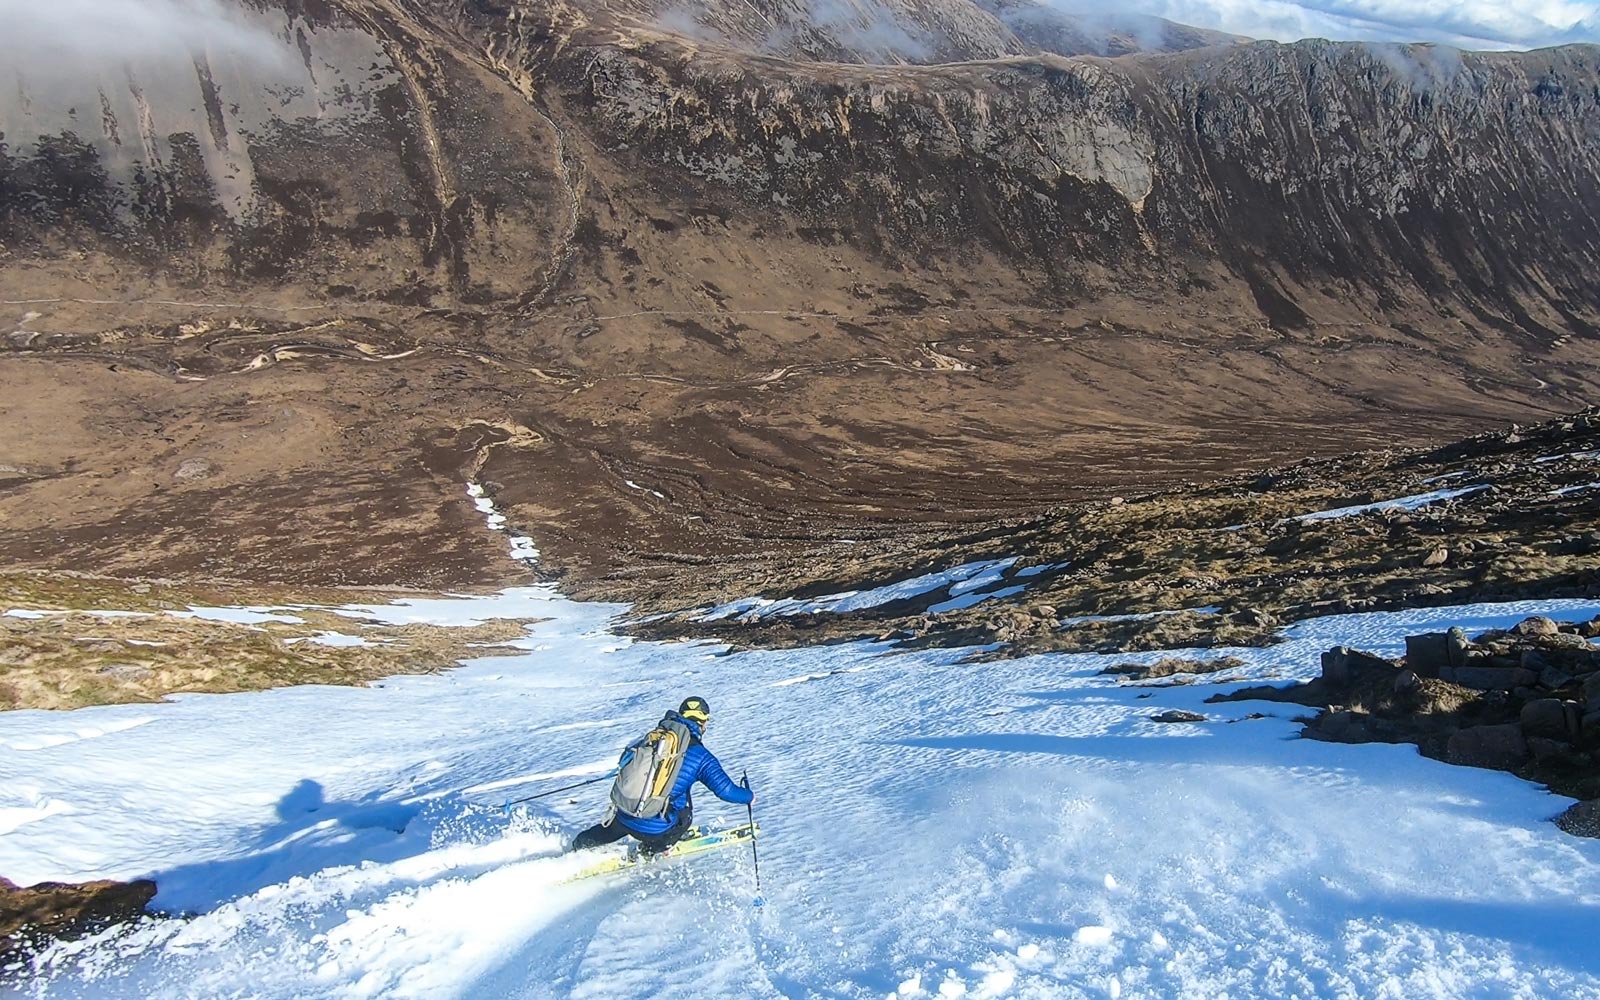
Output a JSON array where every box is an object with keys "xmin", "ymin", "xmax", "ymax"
[{"xmin": 0, "ymin": 0, "xmax": 1600, "ymax": 582}]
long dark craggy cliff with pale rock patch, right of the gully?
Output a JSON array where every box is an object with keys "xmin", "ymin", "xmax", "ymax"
[{"xmin": 521, "ymin": 24, "xmax": 1600, "ymax": 333}]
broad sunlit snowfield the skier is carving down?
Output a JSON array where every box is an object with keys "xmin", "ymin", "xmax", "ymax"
[{"xmin": 0, "ymin": 587, "xmax": 1600, "ymax": 1000}]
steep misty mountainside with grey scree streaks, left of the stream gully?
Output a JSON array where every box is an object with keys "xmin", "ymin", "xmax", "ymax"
[{"xmin": 0, "ymin": 0, "xmax": 576, "ymax": 301}]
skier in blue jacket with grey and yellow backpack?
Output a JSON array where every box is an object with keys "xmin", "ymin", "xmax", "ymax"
[{"xmin": 571, "ymin": 698, "xmax": 755, "ymax": 854}]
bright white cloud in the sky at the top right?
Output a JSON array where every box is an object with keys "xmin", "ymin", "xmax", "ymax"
[{"xmin": 1061, "ymin": 0, "xmax": 1600, "ymax": 48}]
